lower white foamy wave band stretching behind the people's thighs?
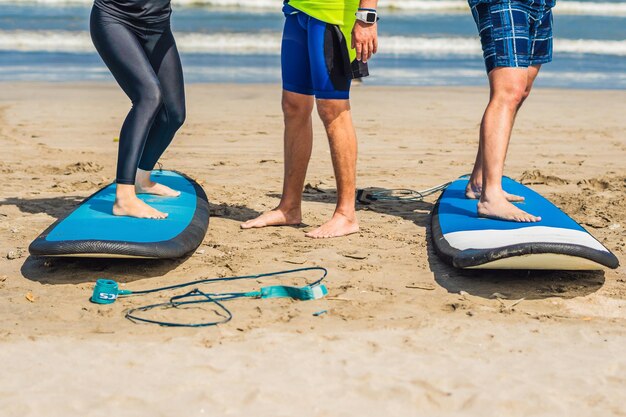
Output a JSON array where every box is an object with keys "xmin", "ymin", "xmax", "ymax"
[{"xmin": 0, "ymin": 31, "xmax": 626, "ymax": 56}]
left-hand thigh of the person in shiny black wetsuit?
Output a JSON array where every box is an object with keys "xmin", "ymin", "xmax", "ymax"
[{"xmin": 90, "ymin": 7, "xmax": 158, "ymax": 101}]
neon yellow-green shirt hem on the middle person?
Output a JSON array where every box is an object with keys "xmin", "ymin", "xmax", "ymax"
[{"xmin": 289, "ymin": 0, "xmax": 359, "ymax": 26}]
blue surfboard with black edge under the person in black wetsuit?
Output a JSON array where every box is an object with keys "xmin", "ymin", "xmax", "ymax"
[{"xmin": 29, "ymin": 171, "xmax": 209, "ymax": 258}]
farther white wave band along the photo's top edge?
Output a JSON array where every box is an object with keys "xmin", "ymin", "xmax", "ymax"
[{"xmin": 0, "ymin": 0, "xmax": 626, "ymax": 16}]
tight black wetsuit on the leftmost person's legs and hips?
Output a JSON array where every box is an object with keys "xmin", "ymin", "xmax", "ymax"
[{"xmin": 90, "ymin": 0, "xmax": 185, "ymax": 184}]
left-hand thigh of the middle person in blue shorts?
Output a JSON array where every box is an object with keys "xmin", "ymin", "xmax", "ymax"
[{"xmin": 281, "ymin": 13, "xmax": 314, "ymax": 95}]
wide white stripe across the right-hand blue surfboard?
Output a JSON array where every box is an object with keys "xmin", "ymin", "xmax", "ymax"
[{"xmin": 443, "ymin": 226, "xmax": 608, "ymax": 252}]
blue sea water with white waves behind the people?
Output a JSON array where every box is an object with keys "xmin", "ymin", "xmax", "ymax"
[{"xmin": 0, "ymin": 0, "xmax": 626, "ymax": 89}]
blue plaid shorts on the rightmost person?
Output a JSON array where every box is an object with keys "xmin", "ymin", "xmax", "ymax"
[{"xmin": 471, "ymin": 0, "xmax": 552, "ymax": 73}]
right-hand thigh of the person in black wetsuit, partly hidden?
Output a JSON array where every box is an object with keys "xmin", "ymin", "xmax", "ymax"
[{"xmin": 145, "ymin": 26, "xmax": 185, "ymax": 119}]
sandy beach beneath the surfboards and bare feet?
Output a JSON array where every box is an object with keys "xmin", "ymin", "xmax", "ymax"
[{"xmin": 0, "ymin": 83, "xmax": 626, "ymax": 417}]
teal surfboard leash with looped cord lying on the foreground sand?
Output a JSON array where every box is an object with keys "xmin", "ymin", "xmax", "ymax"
[{"xmin": 90, "ymin": 266, "xmax": 328, "ymax": 327}]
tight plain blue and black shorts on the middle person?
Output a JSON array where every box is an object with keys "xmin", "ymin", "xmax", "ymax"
[{"xmin": 281, "ymin": 5, "xmax": 367, "ymax": 100}]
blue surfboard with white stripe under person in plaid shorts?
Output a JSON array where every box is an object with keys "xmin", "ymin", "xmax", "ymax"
[{"xmin": 432, "ymin": 177, "xmax": 619, "ymax": 270}]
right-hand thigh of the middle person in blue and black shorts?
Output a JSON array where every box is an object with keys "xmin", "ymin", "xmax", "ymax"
[{"xmin": 308, "ymin": 18, "xmax": 352, "ymax": 100}]
